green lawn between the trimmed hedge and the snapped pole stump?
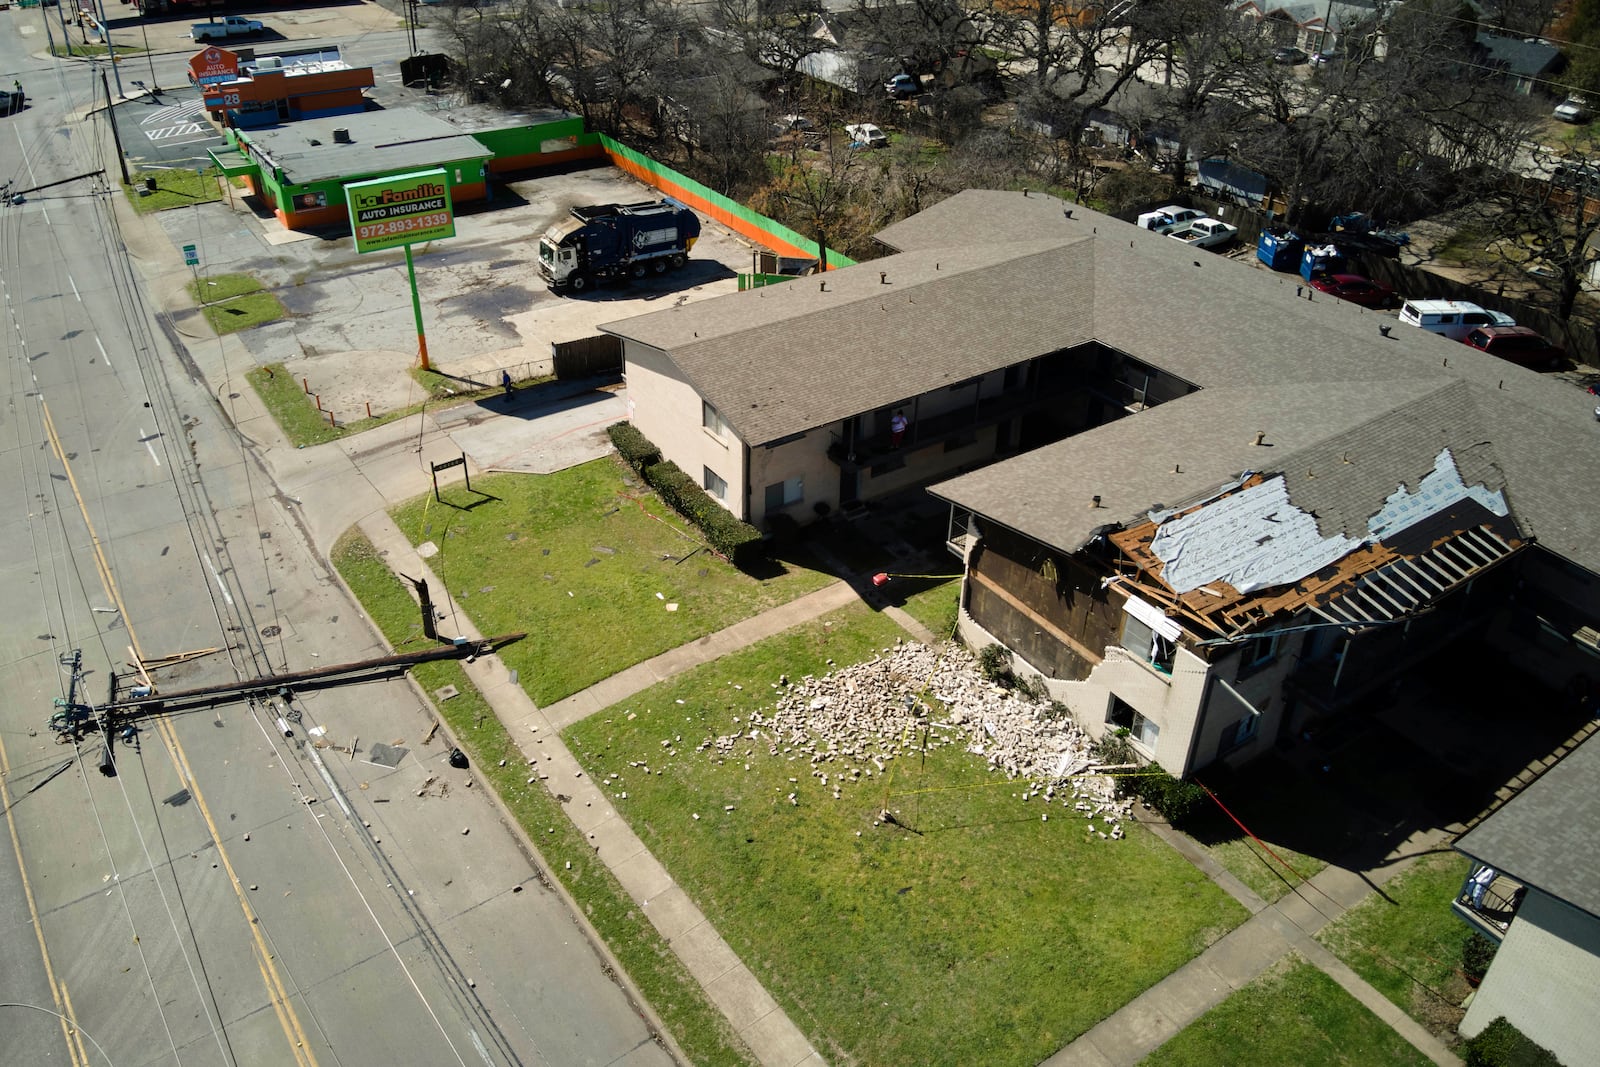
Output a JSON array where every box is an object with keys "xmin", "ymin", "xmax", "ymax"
[{"xmin": 394, "ymin": 456, "xmax": 834, "ymax": 705}]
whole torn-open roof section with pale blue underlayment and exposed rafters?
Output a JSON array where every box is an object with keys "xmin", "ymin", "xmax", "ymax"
[{"xmin": 1109, "ymin": 448, "xmax": 1526, "ymax": 637}]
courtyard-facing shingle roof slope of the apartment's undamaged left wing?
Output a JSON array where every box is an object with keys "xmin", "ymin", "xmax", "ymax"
[{"xmin": 600, "ymin": 241, "xmax": 1094, "ymax": 445}]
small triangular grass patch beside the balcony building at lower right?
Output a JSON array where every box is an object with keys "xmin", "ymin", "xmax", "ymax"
[{"xmin": 1317, "ymin": 851, "xmax": 1472, "ymax": 1032}]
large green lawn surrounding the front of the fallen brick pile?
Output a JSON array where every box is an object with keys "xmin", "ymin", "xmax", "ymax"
[{"xmin": 566, "ymin": 605, "xmax": 1245, "ymax": 1067}]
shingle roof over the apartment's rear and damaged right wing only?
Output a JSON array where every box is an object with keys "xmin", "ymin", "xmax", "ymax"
[{"xmin": 908, "ymin": 190, "xmax": 1600, "ymax": 569}]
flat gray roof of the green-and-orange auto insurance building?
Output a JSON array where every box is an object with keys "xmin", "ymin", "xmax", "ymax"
[{"xmin": 242, "ymin": 110, "xmax": 494, "ymax": 186}]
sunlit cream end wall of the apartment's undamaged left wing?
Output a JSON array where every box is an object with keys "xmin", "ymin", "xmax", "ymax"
[{"xmin": 622, "ymin": 341, "xmax": 747, "ymax": 518}]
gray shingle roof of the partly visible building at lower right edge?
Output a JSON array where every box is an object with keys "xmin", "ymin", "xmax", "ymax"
[{"xmin": 1456, "ymin": 737, "xmax": 1600, "ymax": 918}]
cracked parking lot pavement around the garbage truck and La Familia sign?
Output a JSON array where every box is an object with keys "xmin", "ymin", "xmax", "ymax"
[{"xmin": 158, "ymin": 166, "xmax": 752, "ymax": 421}]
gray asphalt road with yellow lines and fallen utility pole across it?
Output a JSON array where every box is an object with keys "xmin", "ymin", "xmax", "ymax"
[{"xmin": 0, "ymin": 13, "xmax": 670, "ymax": 1067}]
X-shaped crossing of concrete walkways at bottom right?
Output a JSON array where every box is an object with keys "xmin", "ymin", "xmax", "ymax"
[{"xmin": 1045, "ymin": 819, "xmax": 1461, "ymax": 1067}]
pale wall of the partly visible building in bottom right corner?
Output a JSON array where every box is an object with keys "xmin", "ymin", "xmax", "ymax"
[{"xmin": 1461, "ymin": 889, "xmax": 1600, "ymax": 1064}]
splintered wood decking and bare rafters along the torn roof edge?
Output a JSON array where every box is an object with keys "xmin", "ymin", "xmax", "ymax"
[{"xmin": 1107, "ymin": 489, "xmax": 1528, "ymax": 637}]
